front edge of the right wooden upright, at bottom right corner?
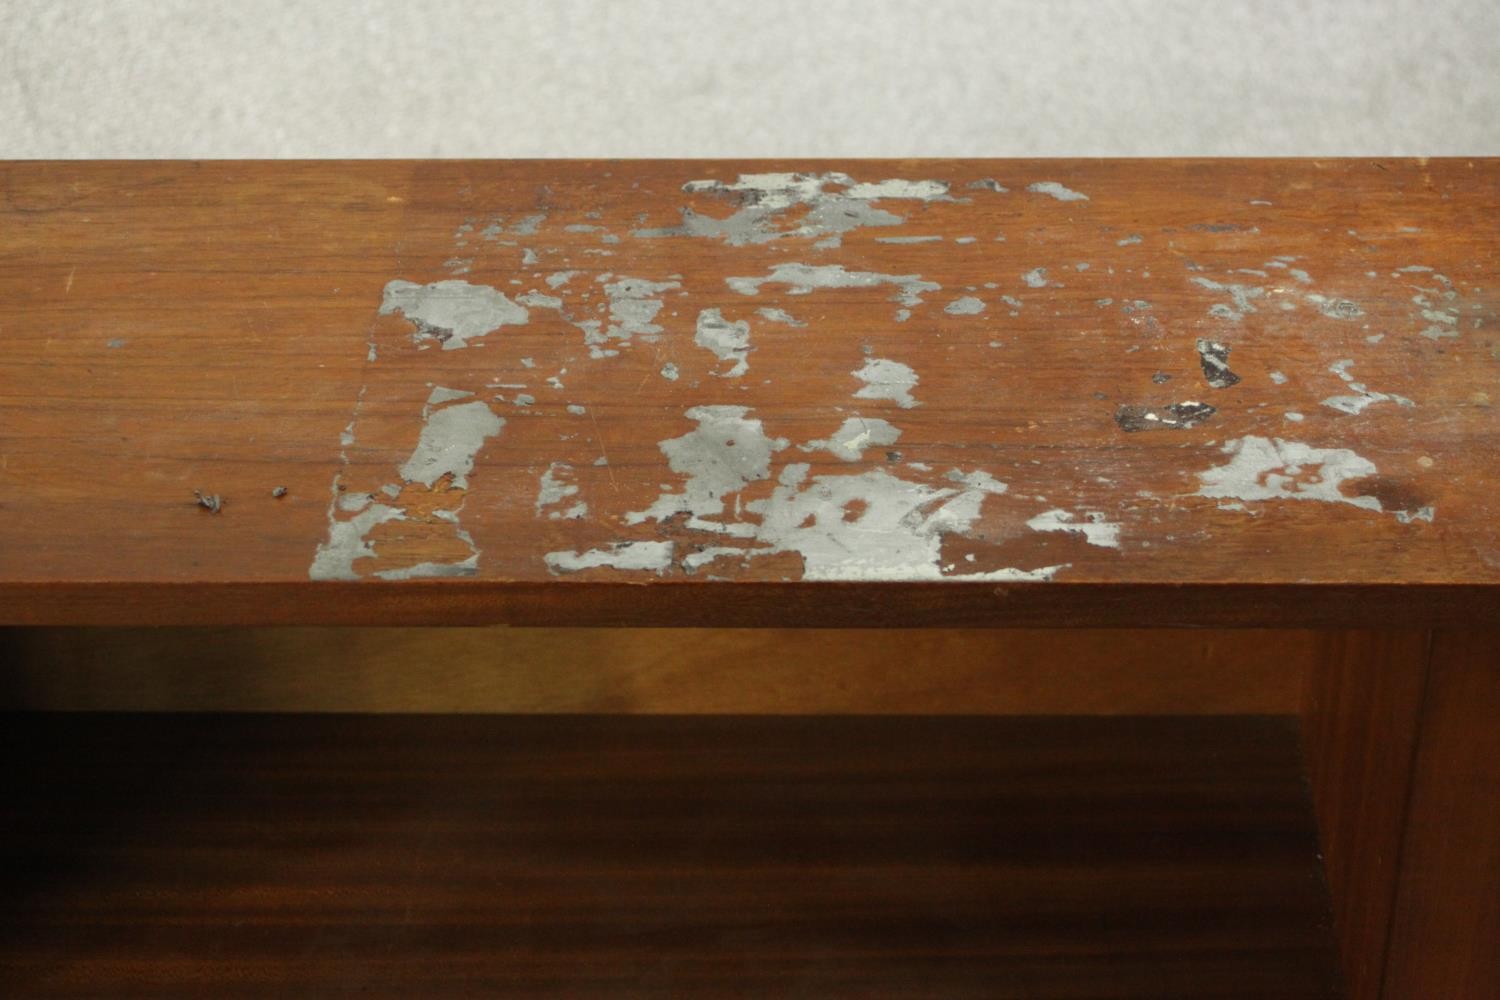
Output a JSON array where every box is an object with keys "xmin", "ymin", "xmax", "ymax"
[{"xmin": 1382, "ymin": 633, "xmax": 1500, "ymax": 1000}]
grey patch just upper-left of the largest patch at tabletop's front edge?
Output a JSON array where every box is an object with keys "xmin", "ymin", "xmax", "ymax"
[{"xmin": 626, "ymin": 406, "xmax": 788, "ymax": 535}]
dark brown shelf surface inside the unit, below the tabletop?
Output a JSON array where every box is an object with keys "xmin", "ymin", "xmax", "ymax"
[{"xmin": 0, "ymin": 715, "xmax": 1338, "ymax": 1000}]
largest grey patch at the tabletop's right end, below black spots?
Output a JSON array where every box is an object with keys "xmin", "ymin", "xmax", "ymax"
[{"xmin": 1197, "ymin": 436, "xmax": 1380, "ymax": 511}]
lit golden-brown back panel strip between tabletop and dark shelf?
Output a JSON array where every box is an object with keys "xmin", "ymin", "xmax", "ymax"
[{"xmin": 0, "ymin": 628, "xmax": 1323, "ymax": 715}]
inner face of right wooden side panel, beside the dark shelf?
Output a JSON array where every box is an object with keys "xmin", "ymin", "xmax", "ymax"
[{"xmin": 1302, "ymin": 631, "xmax": 1436, "ymax": 1000}]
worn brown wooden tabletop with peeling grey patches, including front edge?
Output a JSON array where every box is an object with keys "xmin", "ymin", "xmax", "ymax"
[{"xmin": 0, "ymin": 159, "xmax": 1500, "ymax": 625}]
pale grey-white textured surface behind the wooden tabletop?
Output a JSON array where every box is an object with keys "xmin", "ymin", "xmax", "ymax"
[{"xmin": 0, "ymin": 0, "xmax": 1500, "ymax": 157}]
